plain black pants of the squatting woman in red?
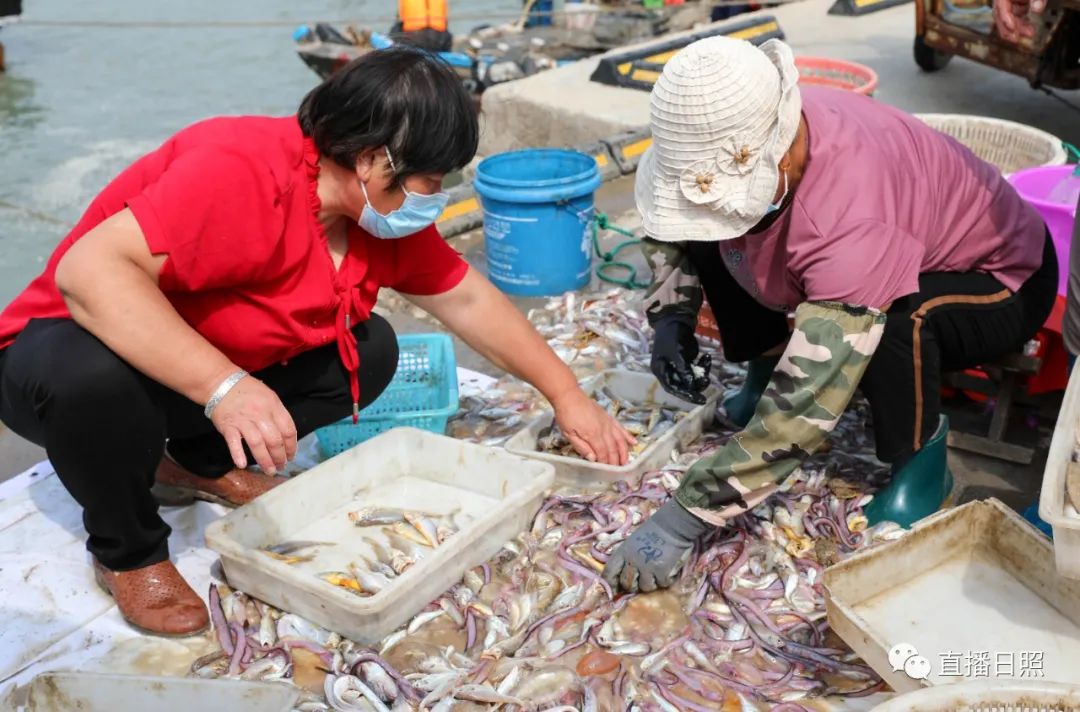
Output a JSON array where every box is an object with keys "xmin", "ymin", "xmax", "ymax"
[{"xmin": 0, "ymin": 314, "xmax": 397, "ymax": 570}]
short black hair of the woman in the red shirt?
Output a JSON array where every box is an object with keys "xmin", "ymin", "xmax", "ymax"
[{"xmin": 297, "ymin": 46, "xmax": 480, "ymax": 180}]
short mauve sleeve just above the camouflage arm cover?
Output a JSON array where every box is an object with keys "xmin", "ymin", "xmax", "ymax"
[{"xmin": 791, "ymin": 220, "xmax": 923, "ymax": 309}]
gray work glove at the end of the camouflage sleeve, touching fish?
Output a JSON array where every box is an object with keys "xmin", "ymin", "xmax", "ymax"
[{"xmin": 604, "ymin": 498, "xmax": 713, "ymax": 593}]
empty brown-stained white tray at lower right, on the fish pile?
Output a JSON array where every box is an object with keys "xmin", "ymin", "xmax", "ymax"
[{"xmin": 823, "ymin": 499, "xmax": 1080, "ymax": 693}]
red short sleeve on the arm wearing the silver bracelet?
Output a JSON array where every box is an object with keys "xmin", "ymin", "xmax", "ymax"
[{"xmin": 127, "ymin": 146, "xmax": 285, "ymax": 292}]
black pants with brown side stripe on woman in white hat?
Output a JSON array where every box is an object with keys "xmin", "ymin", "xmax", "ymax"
[{"xmin": 689, "ymin": 234, "xmax": 1057, "ymax": 465}]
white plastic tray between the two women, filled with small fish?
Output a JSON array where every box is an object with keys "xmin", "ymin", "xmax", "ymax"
[{"xmin": 507, "ymin": 368, "xmax": 720, "ymax": 487}]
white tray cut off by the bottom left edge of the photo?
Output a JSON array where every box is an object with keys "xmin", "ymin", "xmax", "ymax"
[{"xmin": 26, "ymin": 672, "xmax": 300, "ymax": 712}]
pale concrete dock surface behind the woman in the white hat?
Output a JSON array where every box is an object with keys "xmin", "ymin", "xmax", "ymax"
[{"xmin": 481, "ymin": 0, "xmax": 1080, "ymax": 153}]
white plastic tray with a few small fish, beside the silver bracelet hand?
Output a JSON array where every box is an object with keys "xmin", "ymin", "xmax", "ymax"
[{"xmin": 206, "ymin": 428, "xmax": 554, "ymax": 644}]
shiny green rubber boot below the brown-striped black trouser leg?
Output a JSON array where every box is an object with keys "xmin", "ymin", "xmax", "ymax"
[{"xmin": 863, "ymin": 415, "xmax": 953, "ymax": 529}]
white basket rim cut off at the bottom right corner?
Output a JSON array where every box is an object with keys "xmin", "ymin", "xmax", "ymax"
[{"xmin": 870, "ymin": 680, "xmax": 1080, "ymax": 712}]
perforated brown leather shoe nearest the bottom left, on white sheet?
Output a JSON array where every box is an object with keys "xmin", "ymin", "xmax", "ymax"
[{"xmin": 94, "ymin": 559, "xmax": 210, "ymax": 637}]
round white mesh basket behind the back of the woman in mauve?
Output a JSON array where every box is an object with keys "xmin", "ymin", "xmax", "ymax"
[{"xmin": 915, "ymin": 113, "xmax": 1068, "ymax": 175}]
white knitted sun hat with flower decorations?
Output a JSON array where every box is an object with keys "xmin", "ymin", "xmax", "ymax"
[{"xmin": 634, "ymin": 37, "xmax": 802, "ymax": 242}]
